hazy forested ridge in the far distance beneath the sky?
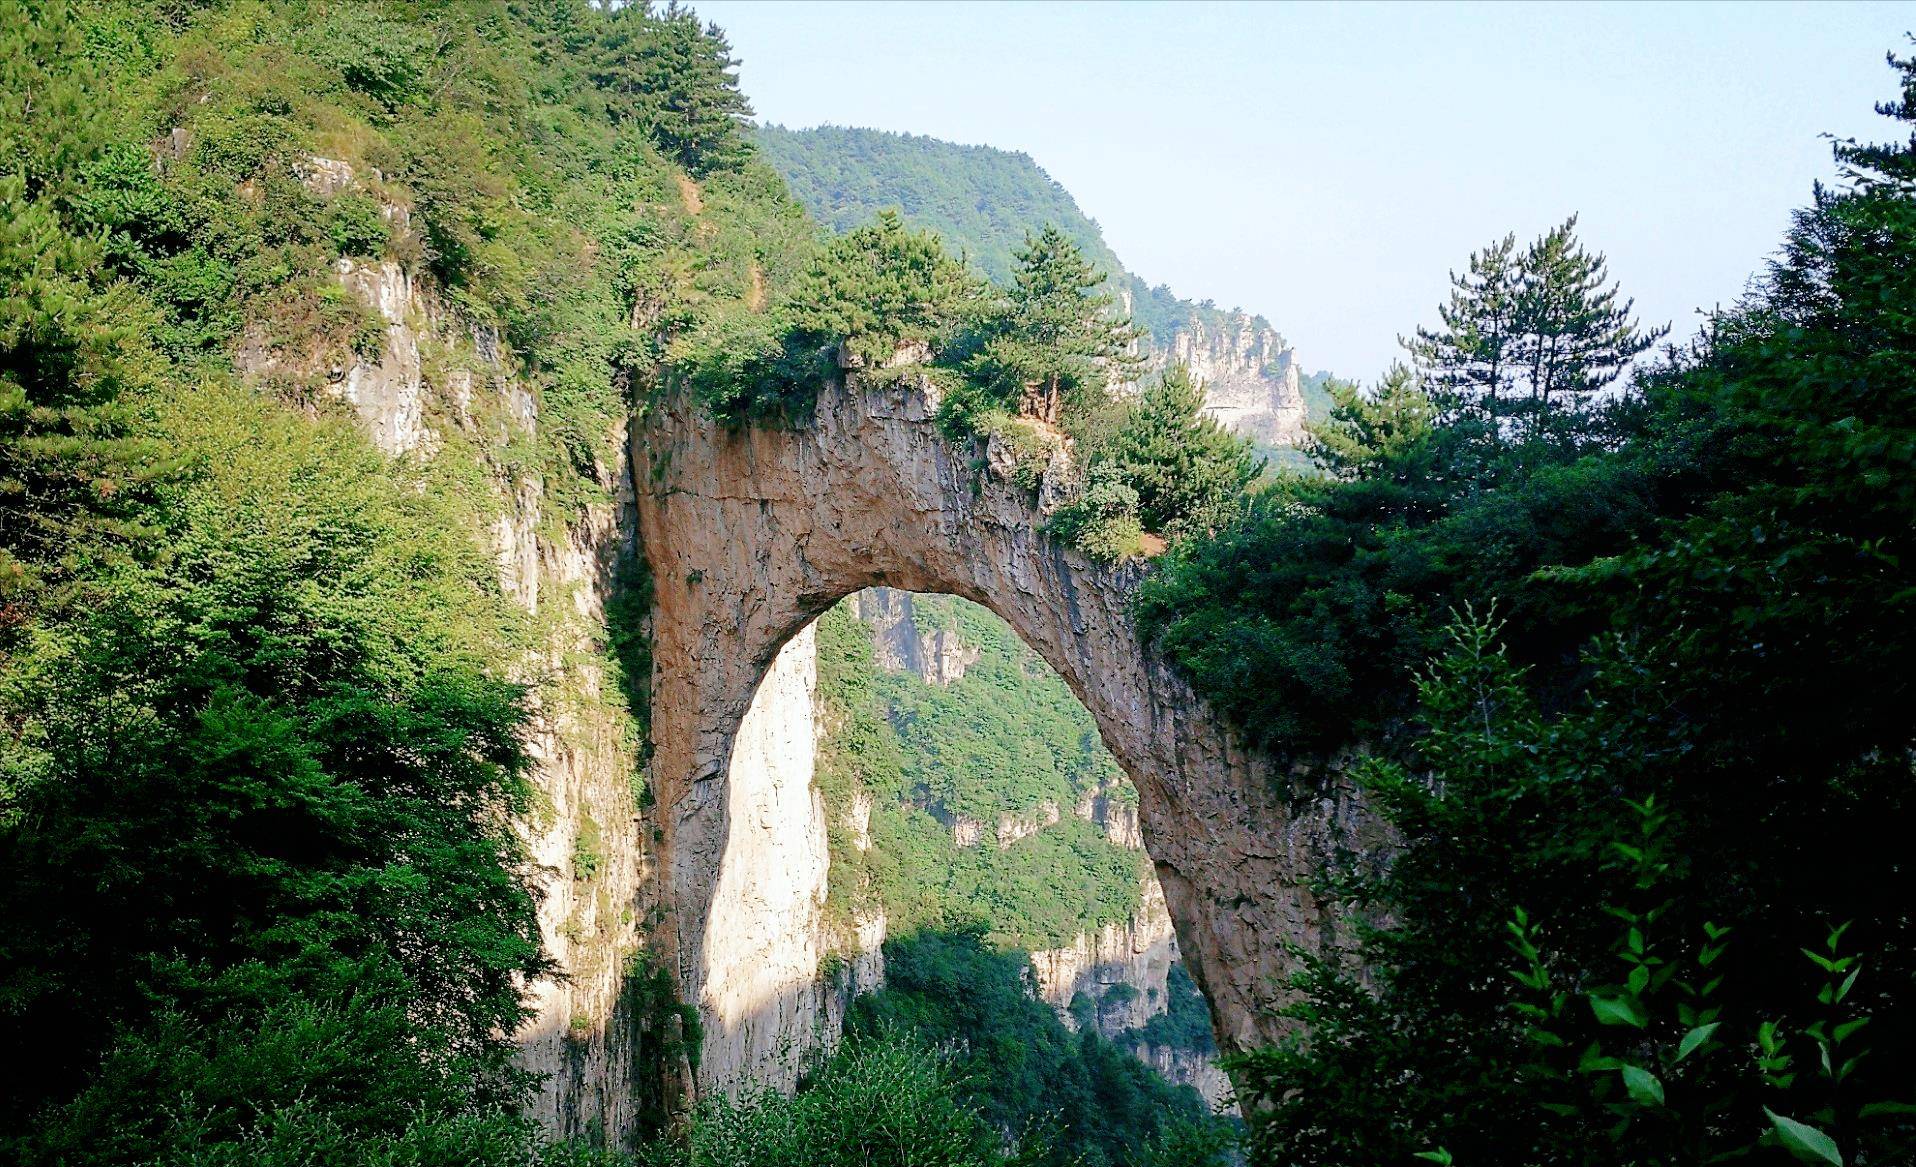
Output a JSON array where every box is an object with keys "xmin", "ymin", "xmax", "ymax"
[{"xmin": 757, "ymin": 126, "xmax": 1268, "ymax": 345}]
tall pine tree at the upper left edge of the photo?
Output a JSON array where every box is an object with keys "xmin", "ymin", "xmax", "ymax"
[{"xmin": 0, "ymin": 4, "xmax": 167, "ymax": 634}]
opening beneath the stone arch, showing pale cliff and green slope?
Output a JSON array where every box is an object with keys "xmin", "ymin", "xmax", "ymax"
[{"xmin": 697, "ymin": 588, "xmax": 1228, "ymax": 1106}]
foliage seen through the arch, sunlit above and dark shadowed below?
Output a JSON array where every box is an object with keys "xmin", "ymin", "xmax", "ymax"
[{"xmin": 818, "ymin": 596, "xmax": 1230, "ymax": 1165}]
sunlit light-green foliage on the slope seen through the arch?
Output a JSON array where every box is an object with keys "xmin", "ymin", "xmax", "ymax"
[{"xmin": 818, "ymin": 596, "xmax": 1144, "ymax": 949}]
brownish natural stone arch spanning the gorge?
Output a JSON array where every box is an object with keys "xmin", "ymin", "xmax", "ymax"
[{"xmin": 632, "ymin": 378, "xmax": 1366, "ymax": 1088}]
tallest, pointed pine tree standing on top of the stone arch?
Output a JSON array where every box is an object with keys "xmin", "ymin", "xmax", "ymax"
[{"xmin": 975, "ymin": 224, "xmax": 1142, "ymax": 425}]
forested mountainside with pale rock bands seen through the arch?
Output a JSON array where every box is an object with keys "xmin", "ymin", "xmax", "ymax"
[{"xmin": 818, "ymin": 588, "xmax": 1224, "ymax": 1102}]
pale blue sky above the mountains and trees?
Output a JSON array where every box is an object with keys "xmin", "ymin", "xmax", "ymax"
[{"xmin": 696, "ymin": 0, "xmax": 1916, "ymax": 381}]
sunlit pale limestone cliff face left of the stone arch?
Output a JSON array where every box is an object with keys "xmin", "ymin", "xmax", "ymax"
[{"xmin": 252, "ymin": 159, "xmax": 653, "ymax": 1136}]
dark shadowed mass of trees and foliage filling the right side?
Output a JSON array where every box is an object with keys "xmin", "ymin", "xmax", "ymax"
[{"xmin": 1144, "ymin": 47, "xmax": 1916, "ymax": 1165}]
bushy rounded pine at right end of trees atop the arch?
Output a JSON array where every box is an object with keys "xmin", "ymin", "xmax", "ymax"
[{"xmin": 1111, "ymin": 364, "xmax": 1259, "ymax": 531}]
